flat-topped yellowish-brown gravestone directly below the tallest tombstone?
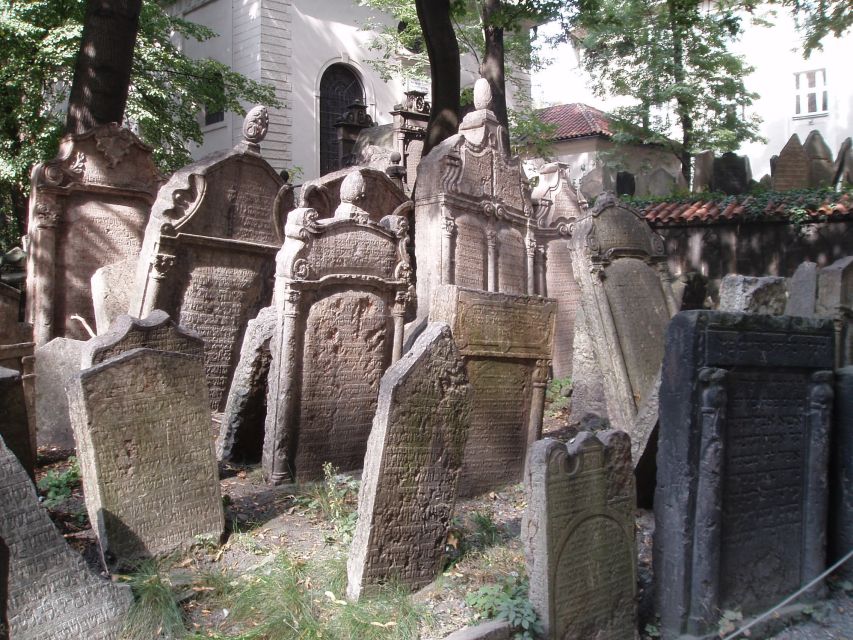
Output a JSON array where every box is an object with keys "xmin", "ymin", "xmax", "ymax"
[{"xmin": 429, "ymin": 285, "xmax": 556, "ymax": 497}]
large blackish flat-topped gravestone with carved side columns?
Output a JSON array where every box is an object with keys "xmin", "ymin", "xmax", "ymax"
[{"xmin": 654, "ymin": 311, "xmax": 833, "ymax": 638}]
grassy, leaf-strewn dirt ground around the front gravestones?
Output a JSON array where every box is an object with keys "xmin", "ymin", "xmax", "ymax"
[{"xmin": 30, "ymin": 396, "xmax": 853, "ymax": 640}]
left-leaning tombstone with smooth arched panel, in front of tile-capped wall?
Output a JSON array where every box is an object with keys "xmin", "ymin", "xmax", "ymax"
[{"xmin": 571, "ymin": 194, "xmax": 678, "ymax": 456}]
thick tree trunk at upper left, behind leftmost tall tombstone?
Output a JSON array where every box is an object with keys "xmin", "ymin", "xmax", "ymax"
[{"xmin": 65, "ymin": 0, "xmax": 142, "ymax": 133}]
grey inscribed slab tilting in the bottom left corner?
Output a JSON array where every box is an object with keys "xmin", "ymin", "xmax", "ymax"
[{"xmin": 0, "ymin": 432, "xmax": 133, "ymax": 640}]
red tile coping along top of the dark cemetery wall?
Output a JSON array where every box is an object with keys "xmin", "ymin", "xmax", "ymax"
[{"xmin": 643, "ymin": 192, "xmax": 853, "ymax": 226}]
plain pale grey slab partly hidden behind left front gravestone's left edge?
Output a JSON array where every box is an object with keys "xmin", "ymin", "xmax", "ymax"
[{"xmin": 35, "ymin": 338, "xmax": 84, "ymax": 451}]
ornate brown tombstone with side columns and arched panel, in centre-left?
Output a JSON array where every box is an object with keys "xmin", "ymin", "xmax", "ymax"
[{"xmin": 262, "ymin": 203, "xmax": 411, "ymax": 484}]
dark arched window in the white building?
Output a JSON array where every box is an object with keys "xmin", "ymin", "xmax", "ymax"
[{"xmin": 320, "ymin": 64, "xmax": 364, "ymax": 175}]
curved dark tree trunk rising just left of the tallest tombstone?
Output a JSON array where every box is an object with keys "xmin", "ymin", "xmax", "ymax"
[{"xmin": 415, "ymin": 0, "xmax": 461, "ymax": 156}]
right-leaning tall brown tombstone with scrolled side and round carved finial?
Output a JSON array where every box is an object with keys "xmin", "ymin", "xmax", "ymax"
[{"xmin": 129, "ymin": 107, "xmax": 289, "ymax": 411}]
